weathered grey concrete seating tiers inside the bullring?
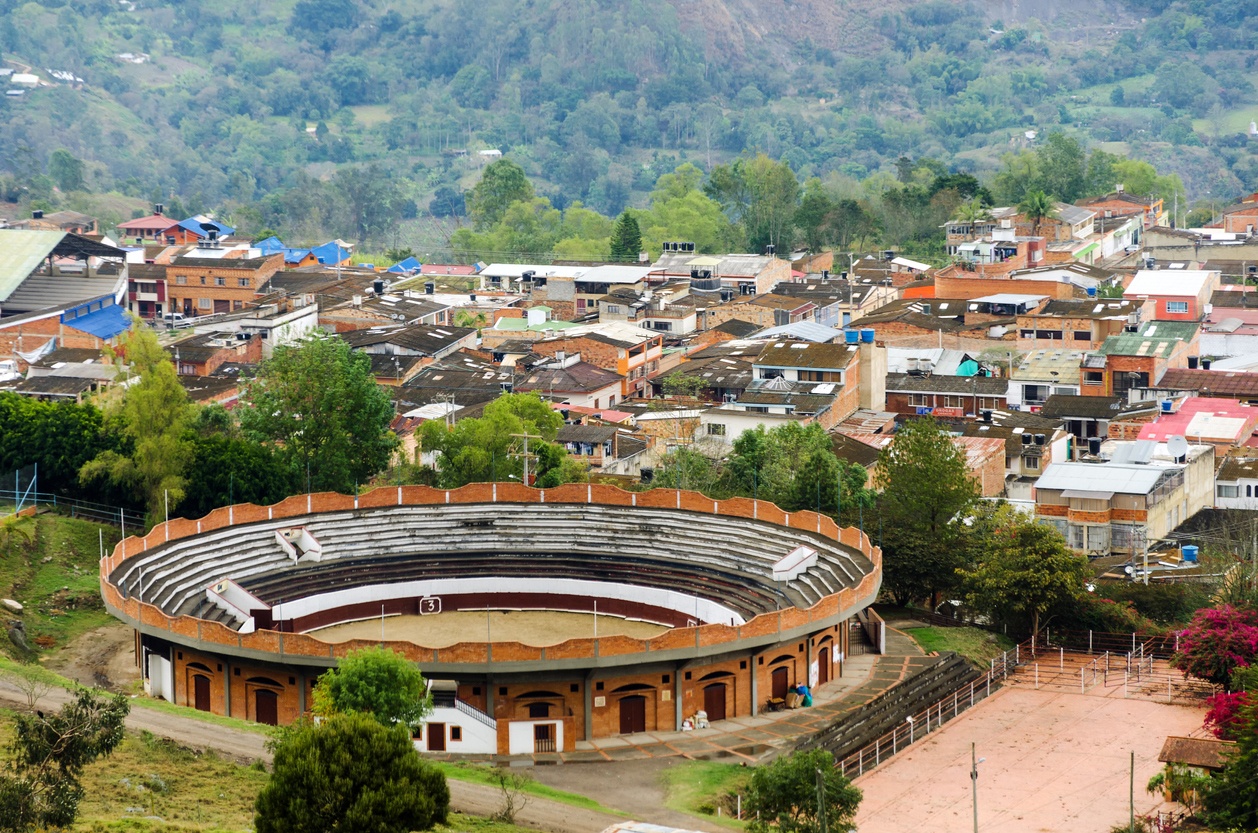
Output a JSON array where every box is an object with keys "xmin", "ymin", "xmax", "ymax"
[{"xmin": 109, "ymin": 502, "xmax": 873, "ymax": 627}]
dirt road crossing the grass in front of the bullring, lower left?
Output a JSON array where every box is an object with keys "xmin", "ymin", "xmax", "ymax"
[{"xmin": 0, "ymin": 678, "xmax": 624, "ymax": 833}]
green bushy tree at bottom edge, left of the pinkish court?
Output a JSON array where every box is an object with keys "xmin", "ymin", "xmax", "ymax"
[{"xmin": 742, "ymin": 749, "xmax": 862, "ymax": 833}]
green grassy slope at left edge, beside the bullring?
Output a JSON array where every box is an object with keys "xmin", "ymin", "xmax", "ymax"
[{"xmin": 0, "ymin": 513, "xmax": 118, "ymax": 661}]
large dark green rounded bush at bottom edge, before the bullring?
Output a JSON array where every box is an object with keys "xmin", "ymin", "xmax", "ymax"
[{"xmin": 254, "ymin": 712, "xmax": 450, "ymax": 833}]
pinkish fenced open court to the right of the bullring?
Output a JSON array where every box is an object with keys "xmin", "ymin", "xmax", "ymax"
[{"xmin": 857, "ymin": 687, "xmax": 1204, "ymax": 833}]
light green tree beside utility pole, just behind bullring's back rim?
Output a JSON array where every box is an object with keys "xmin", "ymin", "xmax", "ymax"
[{"xmin": 419, "ymin": 393, "xmax": 585, "ymax": 488}]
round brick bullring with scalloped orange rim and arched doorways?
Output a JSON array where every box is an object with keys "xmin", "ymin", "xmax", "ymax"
[{"xmin": 101, "ymin": 483, "xmax": 882, "ymax": 754}]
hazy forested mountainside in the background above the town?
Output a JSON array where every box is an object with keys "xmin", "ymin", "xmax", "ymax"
[{"xmin": 0, "ymin": 0, "xmax": 1258, "ymax": 249}]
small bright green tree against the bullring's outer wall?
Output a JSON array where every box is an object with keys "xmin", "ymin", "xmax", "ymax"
[{"xmin": 313, "ymin": 647, "xmax": 433, "ymax": 729}]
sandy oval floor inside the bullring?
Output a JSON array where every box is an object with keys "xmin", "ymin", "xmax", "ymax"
[{"xmin": 308, "ymin": 610, "xmax": 668, "ymax": 648}]
